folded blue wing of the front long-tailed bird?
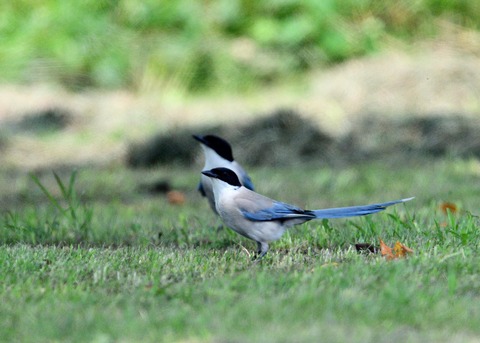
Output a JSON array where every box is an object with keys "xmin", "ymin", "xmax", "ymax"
[{"xmin": 242, "ymin": 201, "xmax": 315, "ymax": 222}]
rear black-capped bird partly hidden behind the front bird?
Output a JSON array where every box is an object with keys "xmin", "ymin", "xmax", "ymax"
[{"xmin": 193, "ymin": 135, "xmax": 254, "ymax": 214}]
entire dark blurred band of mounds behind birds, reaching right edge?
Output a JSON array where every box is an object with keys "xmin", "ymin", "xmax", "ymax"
[{"xmin": 127, "ymin": 110, "xmax": 480, "ymax": 167}]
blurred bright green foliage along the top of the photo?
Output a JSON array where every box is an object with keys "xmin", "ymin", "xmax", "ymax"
[{"xmin": 0, "ymin": 0, "xmax": 480, "ymax": 91}]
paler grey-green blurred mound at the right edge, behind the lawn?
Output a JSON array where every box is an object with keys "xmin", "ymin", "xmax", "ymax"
[{"xmin": 337, "ymin": 114, "xmax": 480, "ymax": 162}]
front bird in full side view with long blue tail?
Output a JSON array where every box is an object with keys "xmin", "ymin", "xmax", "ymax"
[{"xmin": 202, "ymin": 167, "xmax": 413, "ymax": 260}]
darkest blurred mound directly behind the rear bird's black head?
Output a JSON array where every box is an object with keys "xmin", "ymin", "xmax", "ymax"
[{"xmin": 126, "ymin": 110, "xmax": 334, "ymax": 167}]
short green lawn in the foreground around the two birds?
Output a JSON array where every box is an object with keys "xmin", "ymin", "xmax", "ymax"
[{"xmin": 0, "ymin": 159, "xmax": 480, "ymax": 342}]
